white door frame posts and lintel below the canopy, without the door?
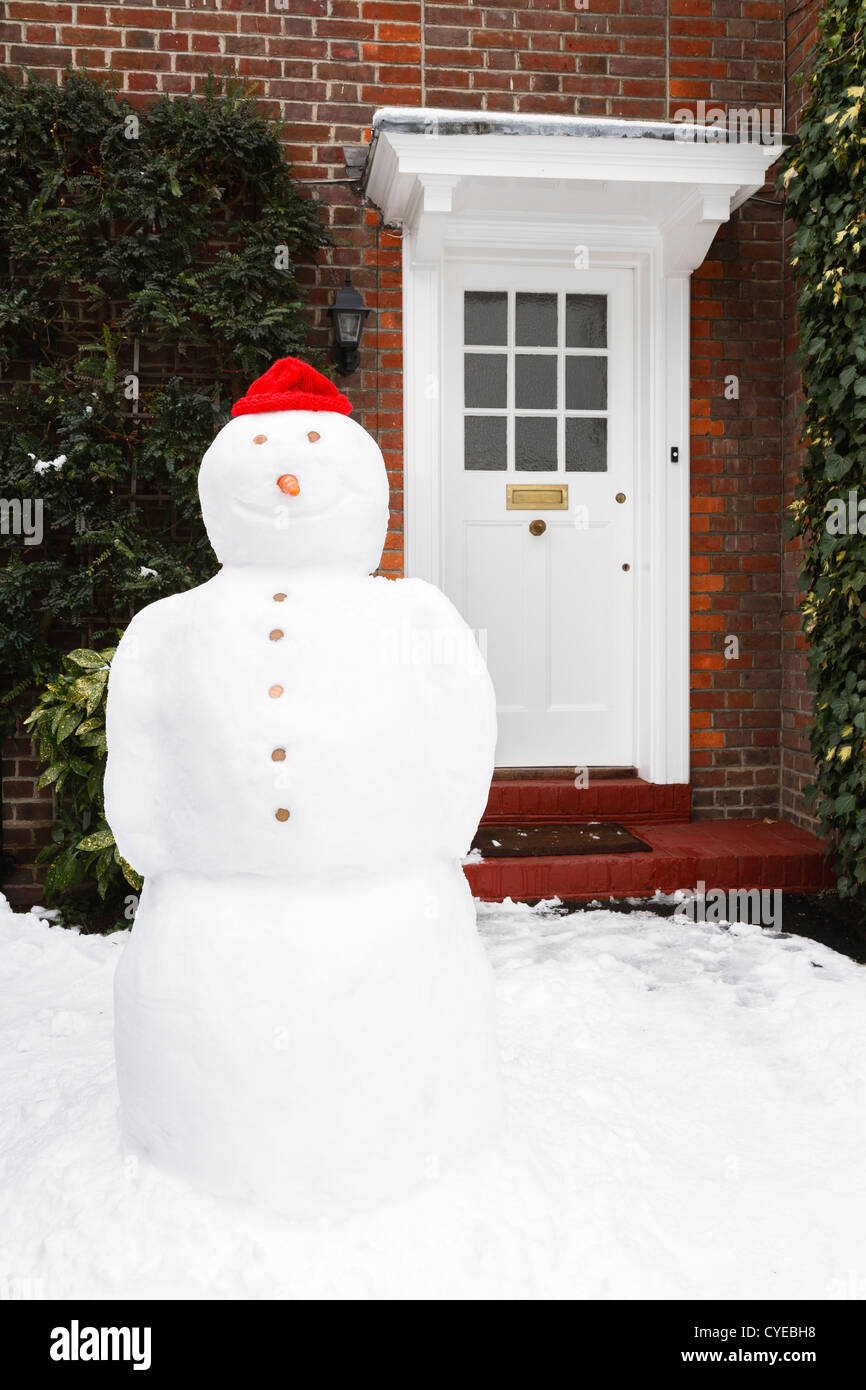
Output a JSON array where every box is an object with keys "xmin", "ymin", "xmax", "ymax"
[{"xmin": 403, "ymin": 221, "xmax": 689, "ymax": 783}]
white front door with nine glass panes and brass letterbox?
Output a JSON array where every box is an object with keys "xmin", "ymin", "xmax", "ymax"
[{"xmin": 442, "ymin": 264, "xmax": 635, "ymax": 767}]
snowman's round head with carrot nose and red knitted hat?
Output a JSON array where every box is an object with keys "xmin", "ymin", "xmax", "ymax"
[{"xmin": 199, "ymin": 357, "xmax": 388, "ymax": 574}]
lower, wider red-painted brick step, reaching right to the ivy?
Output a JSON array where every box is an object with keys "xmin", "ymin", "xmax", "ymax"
[{"xmin": 464, "ymin": 820, "xmax": 833, "ymax": 902}]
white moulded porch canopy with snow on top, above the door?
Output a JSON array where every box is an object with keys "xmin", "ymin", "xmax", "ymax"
[{"xmin": 364, "ymin": 107, "xmax": 781, "ymax": 275}]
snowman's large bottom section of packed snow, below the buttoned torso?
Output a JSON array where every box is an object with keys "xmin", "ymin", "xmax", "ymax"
[{"xmin": 115, "ymin": 863, "xmax": 502, "ymax": 1216}]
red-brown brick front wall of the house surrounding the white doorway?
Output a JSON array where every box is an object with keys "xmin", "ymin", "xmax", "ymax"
[{"xmin": 0, "ymin": 0, "xmax": 798, "ymax": 892}]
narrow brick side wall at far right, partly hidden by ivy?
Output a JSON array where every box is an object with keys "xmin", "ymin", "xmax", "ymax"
[{"xmin": 780, "ymin": 0, "xmax": 820, "ymax": 828}]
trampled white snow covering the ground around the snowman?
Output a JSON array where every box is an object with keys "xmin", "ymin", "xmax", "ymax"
[{"xmin": 0, "ymin": 898, "xmax": 866, "ymax": 1300}]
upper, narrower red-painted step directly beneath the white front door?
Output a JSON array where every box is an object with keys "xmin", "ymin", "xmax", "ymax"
[{"xmin": 481, "ymin": 774, "xmax": 689, "ymax": 826}]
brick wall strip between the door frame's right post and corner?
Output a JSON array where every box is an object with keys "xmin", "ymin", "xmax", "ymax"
[{"xmin": 691, "ymin": 195, "xmax": 783, "ymax": 816}]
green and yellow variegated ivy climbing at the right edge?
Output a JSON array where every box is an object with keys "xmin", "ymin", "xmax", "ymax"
[{"xmin": 781, "ymin": 0, "xmax": 866, "ymax": 897}]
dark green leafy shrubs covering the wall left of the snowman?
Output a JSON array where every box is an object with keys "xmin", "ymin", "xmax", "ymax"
[{"xmin": 0, "ymin": 72, "xmax": 328, "ymax": 922}]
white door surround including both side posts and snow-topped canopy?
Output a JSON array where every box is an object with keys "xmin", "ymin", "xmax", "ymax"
[{"xmin": 367, "ymin": 108, "xmax": 780, "ymax": 783}]
